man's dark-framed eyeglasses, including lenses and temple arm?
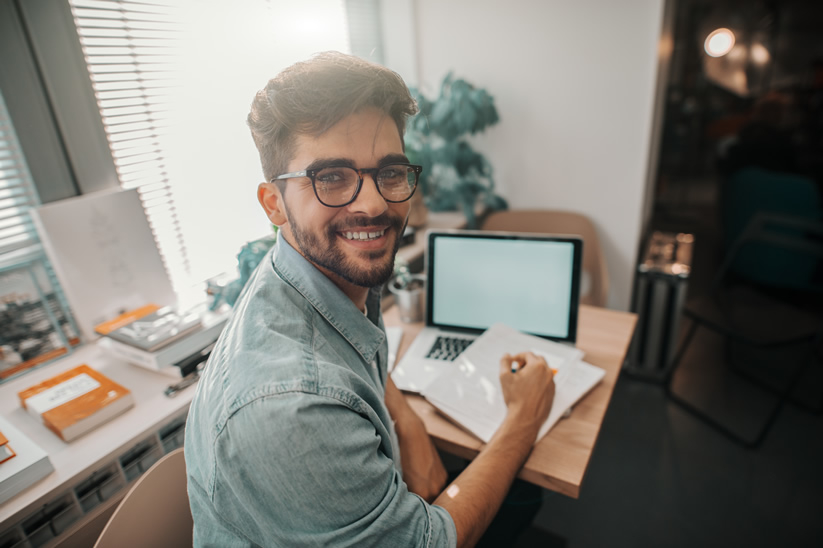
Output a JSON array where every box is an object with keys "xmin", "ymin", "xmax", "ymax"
[{"xmin": 270, "ymin": 164, "xmax": 423, "ymax": 207}]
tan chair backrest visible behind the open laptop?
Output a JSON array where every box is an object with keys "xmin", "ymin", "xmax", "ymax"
[{"xmin": 481, "ymin": 209, "xmax": 609, "ymax": 306}]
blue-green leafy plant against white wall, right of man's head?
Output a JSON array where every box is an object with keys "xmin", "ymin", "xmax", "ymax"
[{"xmin": 405, "ymin": 73, "xmax": 508, "ymax": 228}]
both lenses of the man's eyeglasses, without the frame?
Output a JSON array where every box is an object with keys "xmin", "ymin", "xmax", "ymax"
[{"xmin": 314, "ymin": 165, "xmax": 417, "ymax": 206}]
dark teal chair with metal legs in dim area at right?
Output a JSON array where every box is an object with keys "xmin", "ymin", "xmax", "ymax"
[{"xmin": 664, "ymin": 170, "xmax": 823, "ymax": 448}]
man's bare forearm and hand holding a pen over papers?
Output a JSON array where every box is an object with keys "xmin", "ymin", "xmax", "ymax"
[{"xmin": 434, "ymin": 352, "xmax": 554, "ymax": 547}]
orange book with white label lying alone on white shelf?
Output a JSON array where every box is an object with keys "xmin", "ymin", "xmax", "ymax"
[{"xmin": 17, "ymin": 365, "xmax": 134, "ymax": 442}]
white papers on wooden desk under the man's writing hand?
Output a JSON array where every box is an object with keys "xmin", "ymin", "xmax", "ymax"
[{"xmin": 423, "ymin": 324, "xmax": 606, "ymax": 442}]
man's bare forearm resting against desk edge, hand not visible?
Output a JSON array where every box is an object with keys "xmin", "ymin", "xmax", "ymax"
[{"xmin": 386, "ymin": 378, "xmax": 448, "ymax": 502}]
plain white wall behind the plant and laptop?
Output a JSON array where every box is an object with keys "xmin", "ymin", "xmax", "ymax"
[{"xmin": 412, "ymin": 0, "xmax": 663, "ymax": 310}]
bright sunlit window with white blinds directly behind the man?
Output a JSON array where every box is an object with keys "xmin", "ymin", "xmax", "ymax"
[{"xmin": 70, "ymin": 0, "xmax": 350, "ymax": 291}]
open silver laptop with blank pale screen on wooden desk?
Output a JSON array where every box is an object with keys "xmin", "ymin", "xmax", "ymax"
[{"xmin": 392, "ymin": 230, "xmax": 583, "ymax": 393}]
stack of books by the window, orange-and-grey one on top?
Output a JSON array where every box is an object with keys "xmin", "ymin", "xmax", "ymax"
[{"xmin": 95, "ymin": 305, "xmax": 228, "ymax": 378}]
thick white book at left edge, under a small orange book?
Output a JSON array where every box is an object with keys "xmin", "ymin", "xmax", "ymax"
[{"xmin": 0, "ymin": 417, "xmax": 54, "ymax": 504}]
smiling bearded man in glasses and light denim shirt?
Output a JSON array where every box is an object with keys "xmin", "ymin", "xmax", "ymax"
[{"xmin": 185, "ymin": 53, "xmax": 554, "ymax": 547}]
